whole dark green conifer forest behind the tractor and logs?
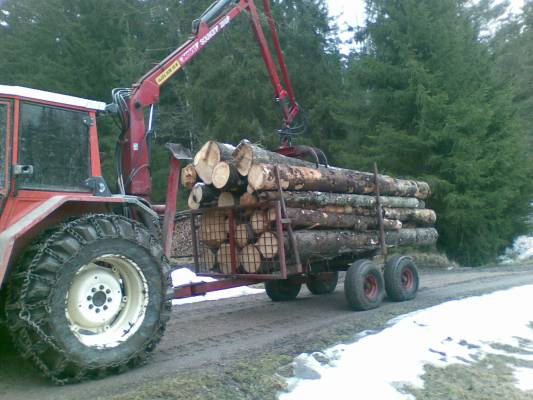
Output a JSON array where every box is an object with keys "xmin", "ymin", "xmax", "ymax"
[{"xmin": 0, "ymin": 0, "xmax": 533, "ymax": 265}]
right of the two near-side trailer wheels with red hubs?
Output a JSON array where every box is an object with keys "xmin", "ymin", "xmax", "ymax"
[{"xmin": 383, "ymin": 255, "xmax": 419, "ymax": 301}]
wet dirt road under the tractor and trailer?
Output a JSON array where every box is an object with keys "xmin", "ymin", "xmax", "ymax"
[{"xmin": 0, "ymin": 265, "xmax": 533, "ymax": 400}]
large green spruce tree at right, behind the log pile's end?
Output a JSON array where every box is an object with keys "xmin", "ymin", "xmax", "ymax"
[{"xmin": 342, "ymin": 0, "xmax": 531, "ymax": 265}]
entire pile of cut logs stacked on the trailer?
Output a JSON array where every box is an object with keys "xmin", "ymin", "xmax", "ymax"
[{"xmin": 182, "ymin": 140, "xmax": 437, "ymax": 274}]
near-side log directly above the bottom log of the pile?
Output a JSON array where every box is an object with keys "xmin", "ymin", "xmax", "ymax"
[{"xmin": 268, "ymin": 208, "xmax": 402, "ymax": 232}]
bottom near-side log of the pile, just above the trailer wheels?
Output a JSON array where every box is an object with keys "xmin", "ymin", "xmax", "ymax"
[{"xmin": 294, "ymin": 228, "xmax": 438, "ymax": 261}]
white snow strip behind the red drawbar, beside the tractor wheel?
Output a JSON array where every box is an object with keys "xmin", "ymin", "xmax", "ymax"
[{"xmin": 172, "ymin": 268, "xmax": 264, "ymax": 305}]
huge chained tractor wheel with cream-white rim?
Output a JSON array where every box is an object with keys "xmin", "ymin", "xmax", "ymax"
[{"xmin": 5, "ymin": 215, "xmax": 172, "ymax": 384}]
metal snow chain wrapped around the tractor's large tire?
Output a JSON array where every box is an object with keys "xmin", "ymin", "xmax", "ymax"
[{"xmin": 6, "ymin": 214, "xmax": 173, "ymax": 385}]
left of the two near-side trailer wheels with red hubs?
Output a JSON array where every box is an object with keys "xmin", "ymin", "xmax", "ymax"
[{"xmin": 344, "ymin": 260, "xmax": 385, "ymax": 311}]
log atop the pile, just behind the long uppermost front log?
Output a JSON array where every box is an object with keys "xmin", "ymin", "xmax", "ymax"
[{"xmin": 233, "ymin": 139, "xmax": 315, "ymax": 176}]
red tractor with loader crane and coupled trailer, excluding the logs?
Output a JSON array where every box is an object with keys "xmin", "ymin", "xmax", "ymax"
[{"xmin": 0, "ymin": 0, "xmax": 426, "ymax": 383}]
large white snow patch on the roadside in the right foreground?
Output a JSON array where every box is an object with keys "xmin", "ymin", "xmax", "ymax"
[{"xmin": 279, "ymin": 285, "xmax": 533, "ymax": 400}]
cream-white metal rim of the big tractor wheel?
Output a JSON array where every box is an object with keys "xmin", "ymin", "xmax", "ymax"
[{"xmin": 65, "ymin": 254, "xmax": 149, "ymax": 348}]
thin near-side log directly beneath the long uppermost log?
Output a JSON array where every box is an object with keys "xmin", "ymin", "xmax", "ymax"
[{"xmin": 259, "ymin": 192, "xmax": 425, "ymax": 209}]
